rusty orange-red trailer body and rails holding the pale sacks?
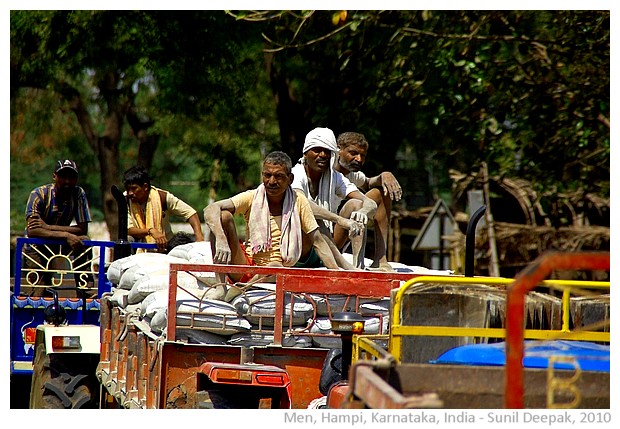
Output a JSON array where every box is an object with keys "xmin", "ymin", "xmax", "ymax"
[{"xmin": 96, "ymin": 264, "xmax": 424, "ymax": 409}]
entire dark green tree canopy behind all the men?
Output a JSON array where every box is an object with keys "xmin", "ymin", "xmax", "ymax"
[{"xmin": 10, "ymin": 10, "xmax": 610, "ymax": 260}]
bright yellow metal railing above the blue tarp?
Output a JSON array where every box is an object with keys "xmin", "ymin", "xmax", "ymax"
[{"xmin": 353, "ymin": 276, "xmax": 610, "ymax": 362}]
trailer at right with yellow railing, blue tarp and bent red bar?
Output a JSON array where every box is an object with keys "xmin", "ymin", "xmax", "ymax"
[{"xmin": 332, "ymin": 252, "xmax": 611, "ymax": 409}]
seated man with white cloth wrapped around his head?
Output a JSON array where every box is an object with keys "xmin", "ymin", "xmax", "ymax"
[{"xmin": 291, "ymin": 128, "xmax": 377, "ymax": 268}]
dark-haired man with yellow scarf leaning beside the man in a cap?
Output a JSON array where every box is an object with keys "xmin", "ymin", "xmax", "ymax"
[{"xmin": 123, "ymin": 166, "xmax": 204, "ymax": 253}]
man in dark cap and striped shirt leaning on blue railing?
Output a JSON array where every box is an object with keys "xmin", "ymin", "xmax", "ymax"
[{"xmin": 26, "ymin": 159, "xmax": 91, "ymax": 286}]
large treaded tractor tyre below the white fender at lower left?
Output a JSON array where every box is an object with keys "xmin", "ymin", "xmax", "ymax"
[{"xmin": 30, "ymin": 343, "xmax": 99, "ymax": 409}]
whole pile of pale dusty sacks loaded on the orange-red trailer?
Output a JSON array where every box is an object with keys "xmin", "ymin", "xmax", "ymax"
[{"xmin": 107, "ymin": 241, "xmax": 429, "ymax": 348}]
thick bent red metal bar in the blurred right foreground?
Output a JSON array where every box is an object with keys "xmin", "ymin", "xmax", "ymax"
[{"xmin": 504, "ymin": 252, "xmax": 610, "ymax": 408}]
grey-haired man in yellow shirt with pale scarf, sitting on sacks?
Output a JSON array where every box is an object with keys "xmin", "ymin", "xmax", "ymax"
[{"xmin": 204, "ymin": 151, "xmax": 338, "ymax": 282}]
